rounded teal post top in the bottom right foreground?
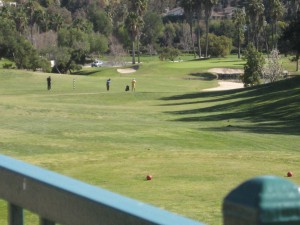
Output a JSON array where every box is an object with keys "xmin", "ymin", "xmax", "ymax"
[{"xmin": 223, "ymin": 176, "xmax": 300, "ymax": 225}]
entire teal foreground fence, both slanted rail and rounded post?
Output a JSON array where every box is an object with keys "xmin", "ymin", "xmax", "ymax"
[{"xmin": 0, "ymin": 155, "xmax": 300, "ymax": 225}]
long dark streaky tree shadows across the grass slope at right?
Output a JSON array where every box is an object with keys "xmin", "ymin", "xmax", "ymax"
[{"xmin": 162, "ymin": 77, "xmax": 300, "ymax": 135}]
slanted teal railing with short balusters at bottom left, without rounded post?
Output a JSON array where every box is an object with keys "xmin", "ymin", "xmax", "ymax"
[{"xmin": 0, "ymin": 155, "xmax": 203, "ymax": 225}]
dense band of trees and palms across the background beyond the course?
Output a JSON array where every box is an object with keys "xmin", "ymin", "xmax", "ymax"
[{"xmin": 0, "ymin": 0, "xmax": 300, "ymax": 73}]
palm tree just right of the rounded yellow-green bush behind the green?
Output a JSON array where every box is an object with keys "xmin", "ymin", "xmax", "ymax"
[{"xmin": 232, "ymin": 8, "xmax": 246, "ymax": 58}]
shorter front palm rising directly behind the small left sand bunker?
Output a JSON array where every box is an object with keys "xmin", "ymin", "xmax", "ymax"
[{"xmin": 125, "ymin": 12, "xmax": 140, "ymax": 64}]
